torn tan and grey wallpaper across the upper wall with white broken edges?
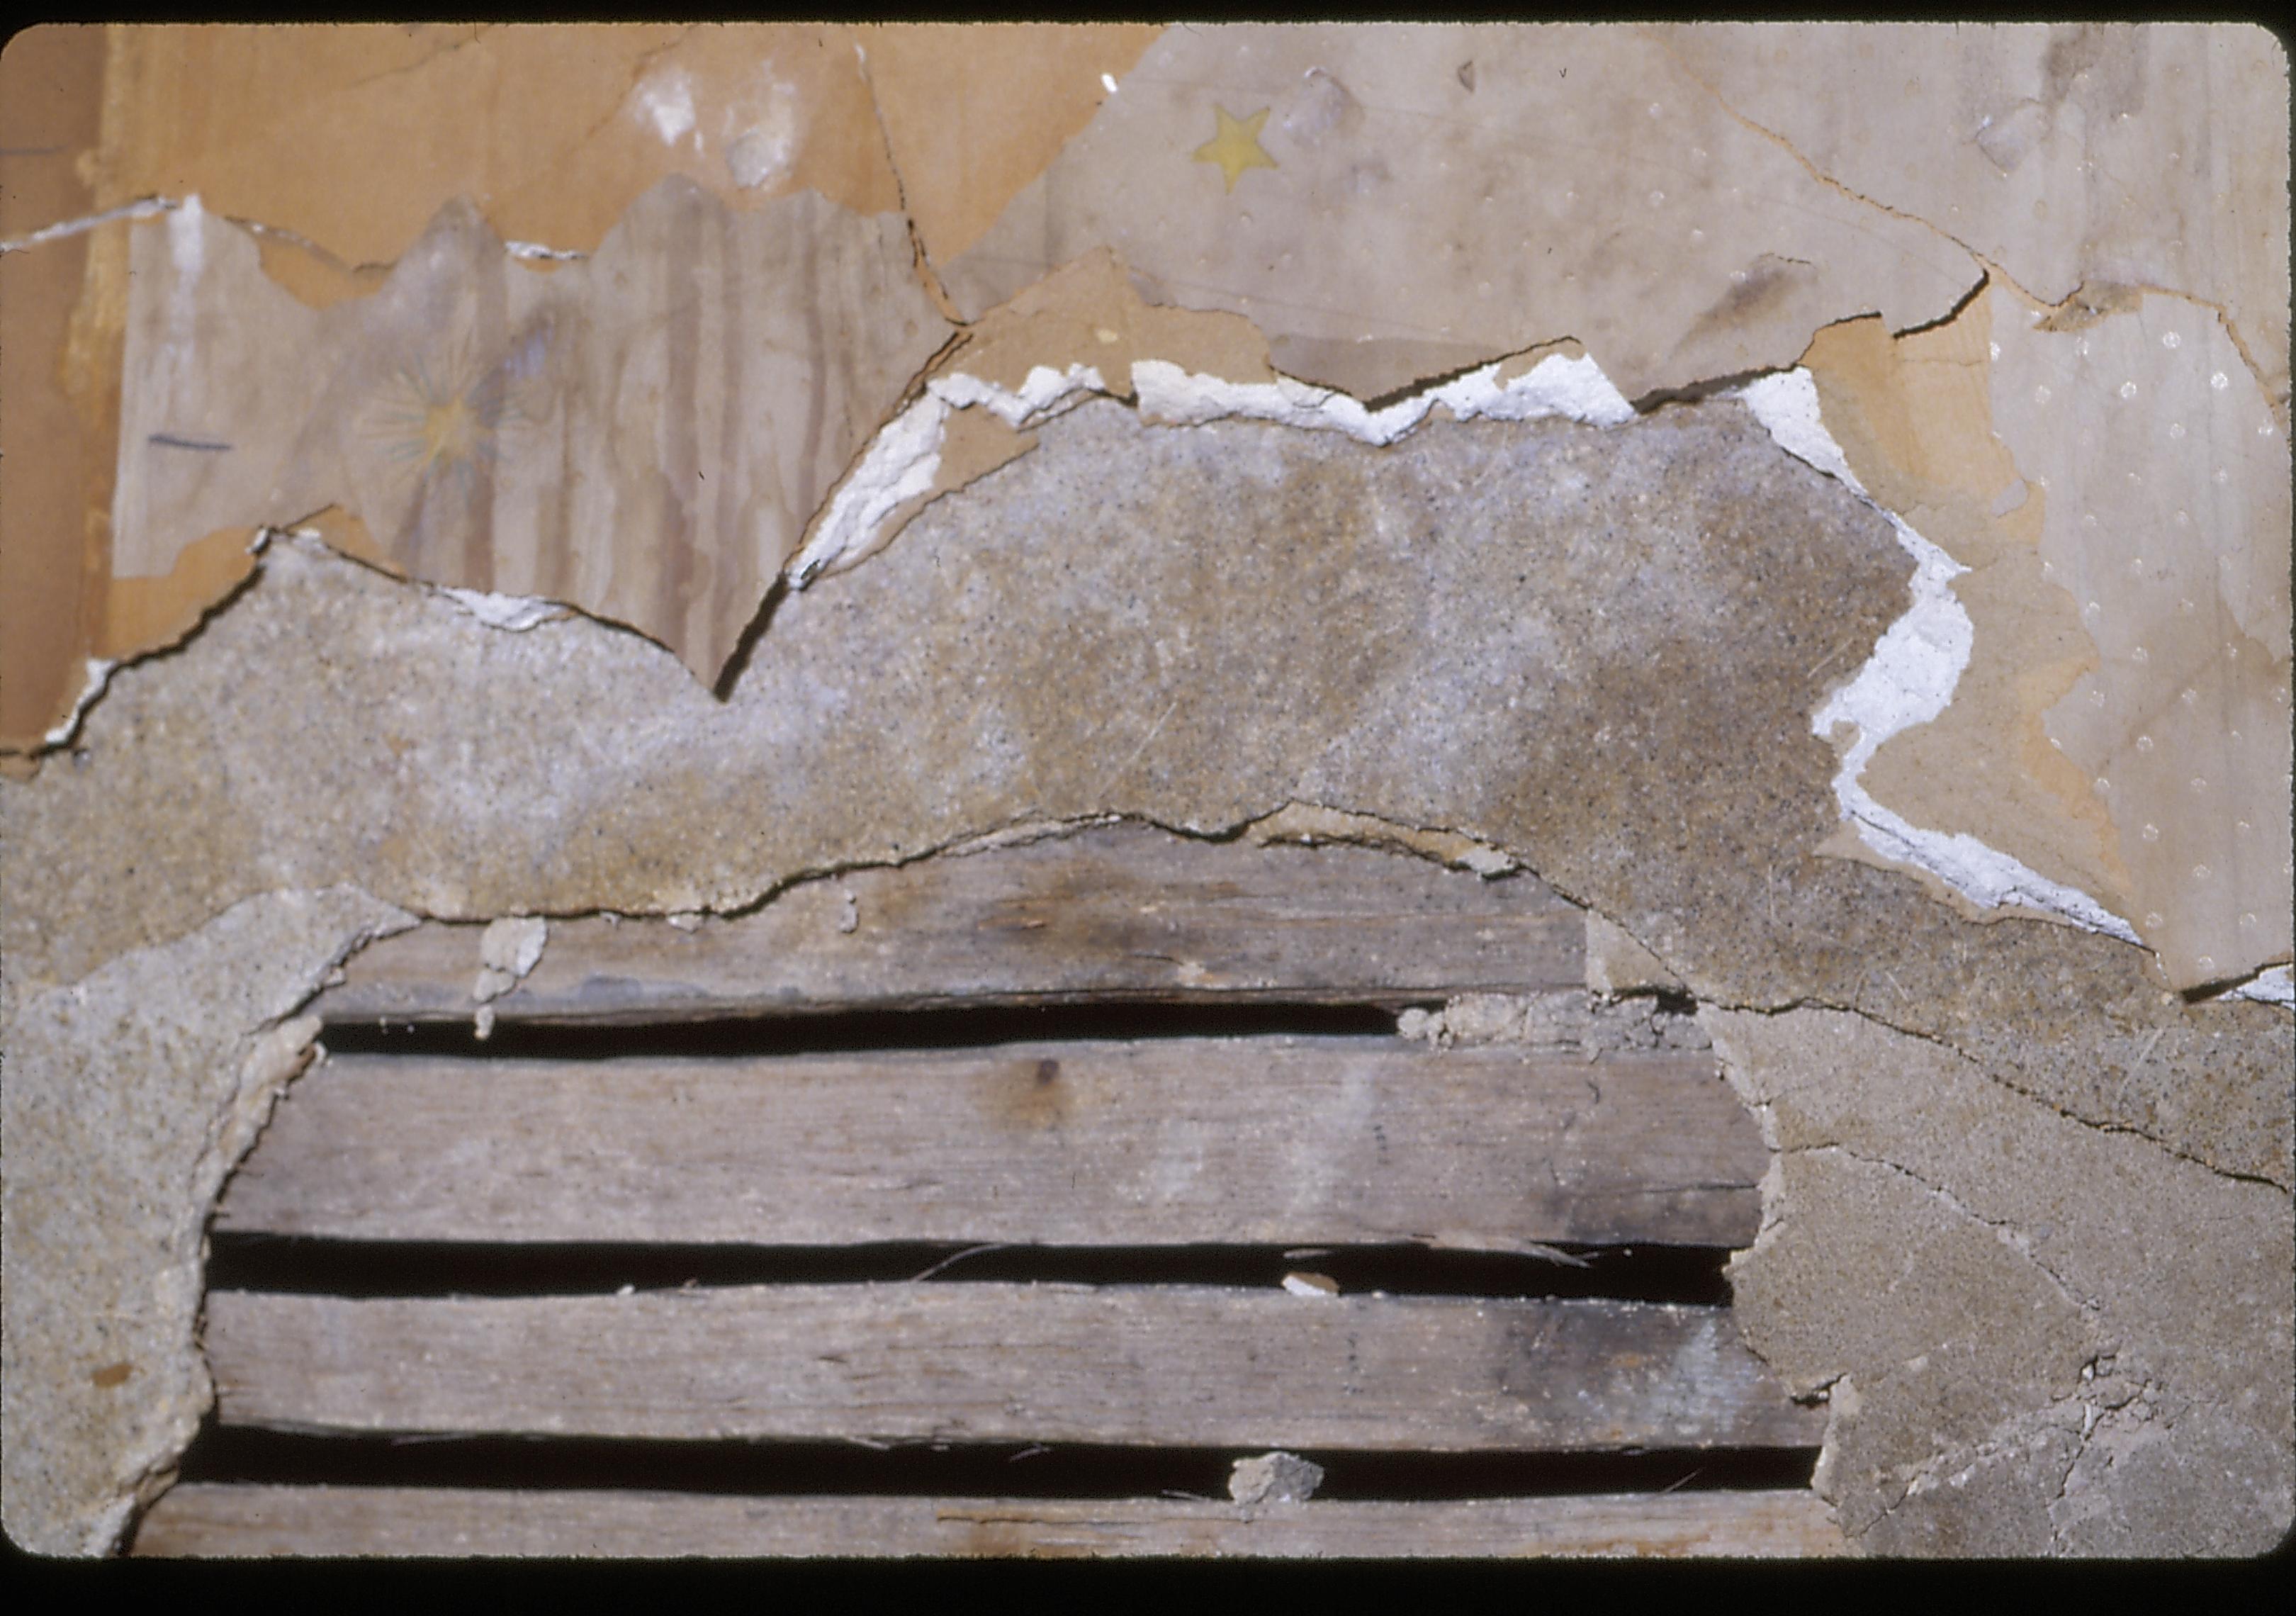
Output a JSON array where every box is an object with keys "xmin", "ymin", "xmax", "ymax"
[{"xmin": 9, "ymin": 26, "xmax": 2292, "ymax": 987}]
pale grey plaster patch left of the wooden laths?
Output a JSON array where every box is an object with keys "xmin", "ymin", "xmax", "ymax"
[{"xmin": 0, "ymin": 881, "xmax": 415, "ymax": 1554}]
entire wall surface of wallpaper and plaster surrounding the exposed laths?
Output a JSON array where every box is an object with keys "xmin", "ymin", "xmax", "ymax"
[{"xmin": 0, "ymin": 28, "xmax": 2296, "ymax": 1552}]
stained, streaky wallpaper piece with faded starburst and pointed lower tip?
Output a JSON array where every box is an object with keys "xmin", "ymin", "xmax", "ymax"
[{"xmin": 113, "ymin": 179, "xmax": 948, "ymax": 684}]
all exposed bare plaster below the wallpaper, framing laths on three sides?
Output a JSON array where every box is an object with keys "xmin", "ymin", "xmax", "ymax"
[{"xmin": 0, "ymin": 400, "xmax": 2296, "ymax": 1552}]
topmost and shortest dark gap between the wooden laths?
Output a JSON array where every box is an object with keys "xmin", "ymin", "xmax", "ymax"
[{"xmin": 319, "ymin": 1003, "xmax": 1396, "ymax": 1060}]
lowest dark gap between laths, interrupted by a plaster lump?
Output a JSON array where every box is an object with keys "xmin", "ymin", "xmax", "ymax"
[{"xmin": 162, "ymin": 1416, "xmax": 1816, "ymax": 1503}]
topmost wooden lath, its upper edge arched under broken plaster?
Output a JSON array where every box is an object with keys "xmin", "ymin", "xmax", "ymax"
[{"xmin": 317, "ymin": 824, "xmax": 1587, "ymax": 1023}]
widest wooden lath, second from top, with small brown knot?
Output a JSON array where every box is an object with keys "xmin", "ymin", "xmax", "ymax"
[{"xmin": 216, "ymin": 1038, "xmax": 1768, "ymax": 1251}]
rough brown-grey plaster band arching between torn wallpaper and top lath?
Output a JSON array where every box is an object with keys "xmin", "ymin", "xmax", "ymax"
[{"xmin": 4, "ymin": 400, "xmax": 2292, "ymax": 1547}]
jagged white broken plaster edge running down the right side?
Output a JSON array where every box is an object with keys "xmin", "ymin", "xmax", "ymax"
[{"xmin": 1735, "ymin": 369, "xmax": 2140, "ymax": 943}]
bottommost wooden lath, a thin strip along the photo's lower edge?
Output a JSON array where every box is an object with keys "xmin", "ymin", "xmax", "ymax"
[{"xmin": 133, "ymin": 1483, "xmax": 1846, "ymax": 1559}]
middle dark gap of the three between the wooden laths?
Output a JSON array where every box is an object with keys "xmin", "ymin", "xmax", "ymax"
[{"xmin": 207, "ymin": 1230, "xmax": 1731, "ymax": 1306}]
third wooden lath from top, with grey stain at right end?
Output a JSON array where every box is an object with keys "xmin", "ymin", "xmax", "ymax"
[{"xmin": 204, "ymin": 1281, "xmax": 1825, "ymax": 1451}]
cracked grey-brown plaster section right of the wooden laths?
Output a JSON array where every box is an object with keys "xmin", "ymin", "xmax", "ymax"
[{"xmin": 1699, "ymin": 1008, "xmax": 2296, "ymax": 1556}]
